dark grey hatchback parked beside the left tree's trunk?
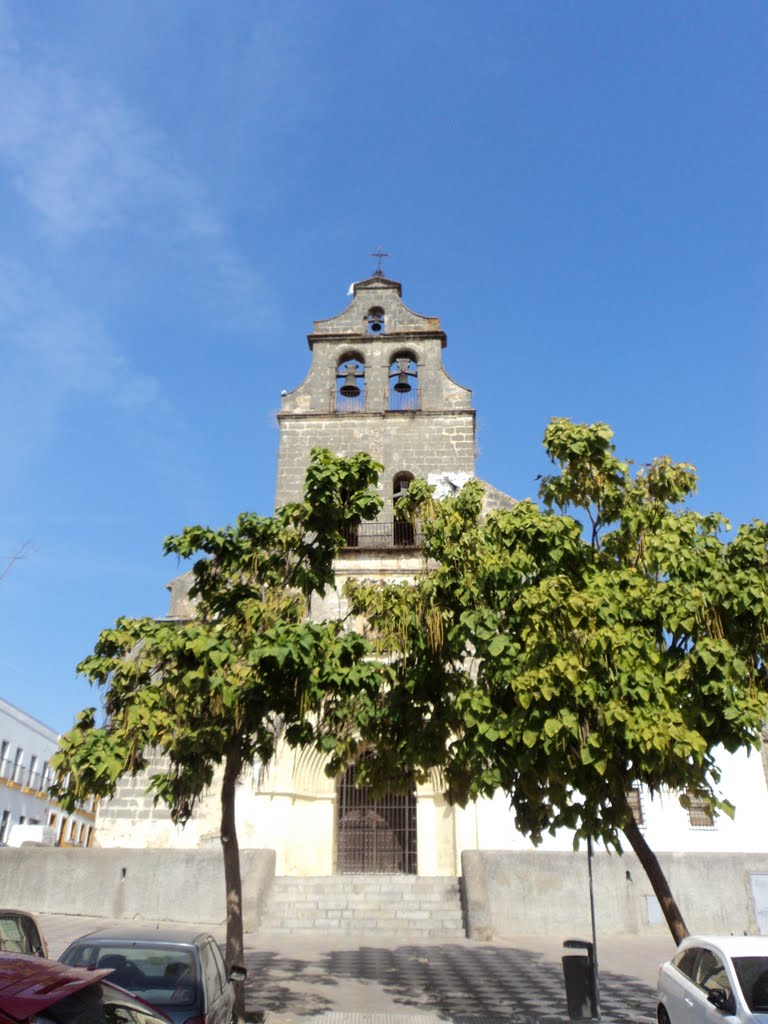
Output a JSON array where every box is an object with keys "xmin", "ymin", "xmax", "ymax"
[{"xmin": 59, "ymin": 928, "xmax": 245, "ymax": 1024}]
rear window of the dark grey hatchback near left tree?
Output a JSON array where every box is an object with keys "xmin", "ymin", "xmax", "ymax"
[{"xmin": 61, "ymin": 942, "xmax": 198, "ymax": 1007}]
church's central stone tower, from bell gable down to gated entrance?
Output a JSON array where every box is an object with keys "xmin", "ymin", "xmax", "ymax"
[{"xmin": 260, "ymin": 269, "xmax": 475, "ymax": 876}]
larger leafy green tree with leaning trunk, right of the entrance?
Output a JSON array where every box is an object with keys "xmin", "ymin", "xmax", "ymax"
[{"xmin": 318, "ymin": 419, "xmax": 768, "ymax": 941}]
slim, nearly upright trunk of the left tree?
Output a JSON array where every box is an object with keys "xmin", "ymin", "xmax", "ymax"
[{"xmin": 221, "ymin": 741, "xmax": 246, "ymax": 1024}]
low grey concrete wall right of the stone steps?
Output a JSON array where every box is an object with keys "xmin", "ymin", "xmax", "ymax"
[{"xmin": 462, "ymin": 850, "xmax": 768, "ymax": 940}]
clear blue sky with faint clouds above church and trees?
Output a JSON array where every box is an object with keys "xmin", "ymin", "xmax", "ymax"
[{"xmin": 0, "ymin": 0, "xmax": 768, "ymax": 729}]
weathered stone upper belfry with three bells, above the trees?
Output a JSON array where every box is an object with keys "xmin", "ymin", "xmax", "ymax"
[{"xmin": 276, "ymin": 270, "xmax": 475, "ymax": 524}]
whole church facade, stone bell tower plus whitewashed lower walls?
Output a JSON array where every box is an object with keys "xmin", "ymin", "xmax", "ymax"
[{"xmin": 96, "ymin": 271, "xmax": 768, "ymax": 876}]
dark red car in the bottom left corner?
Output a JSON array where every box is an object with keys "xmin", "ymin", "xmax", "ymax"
[{"xmin": 0, "ymin": 952, "xmax": 169, "ymax": 1024}]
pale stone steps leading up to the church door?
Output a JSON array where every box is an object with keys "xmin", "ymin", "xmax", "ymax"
[{"xmin": 261, "ymin": 874, "xmax": 465, "ymax": 939}]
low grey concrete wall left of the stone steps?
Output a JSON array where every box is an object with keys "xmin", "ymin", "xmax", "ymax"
[{"xmin": 0, "ymin": 847, "xmax": 274, "ymax": 931}]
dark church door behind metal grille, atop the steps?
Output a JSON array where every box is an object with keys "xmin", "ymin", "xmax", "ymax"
[{"xmin": 336, "ymin": 765, "xmax": 416, "ymax": 874}]
